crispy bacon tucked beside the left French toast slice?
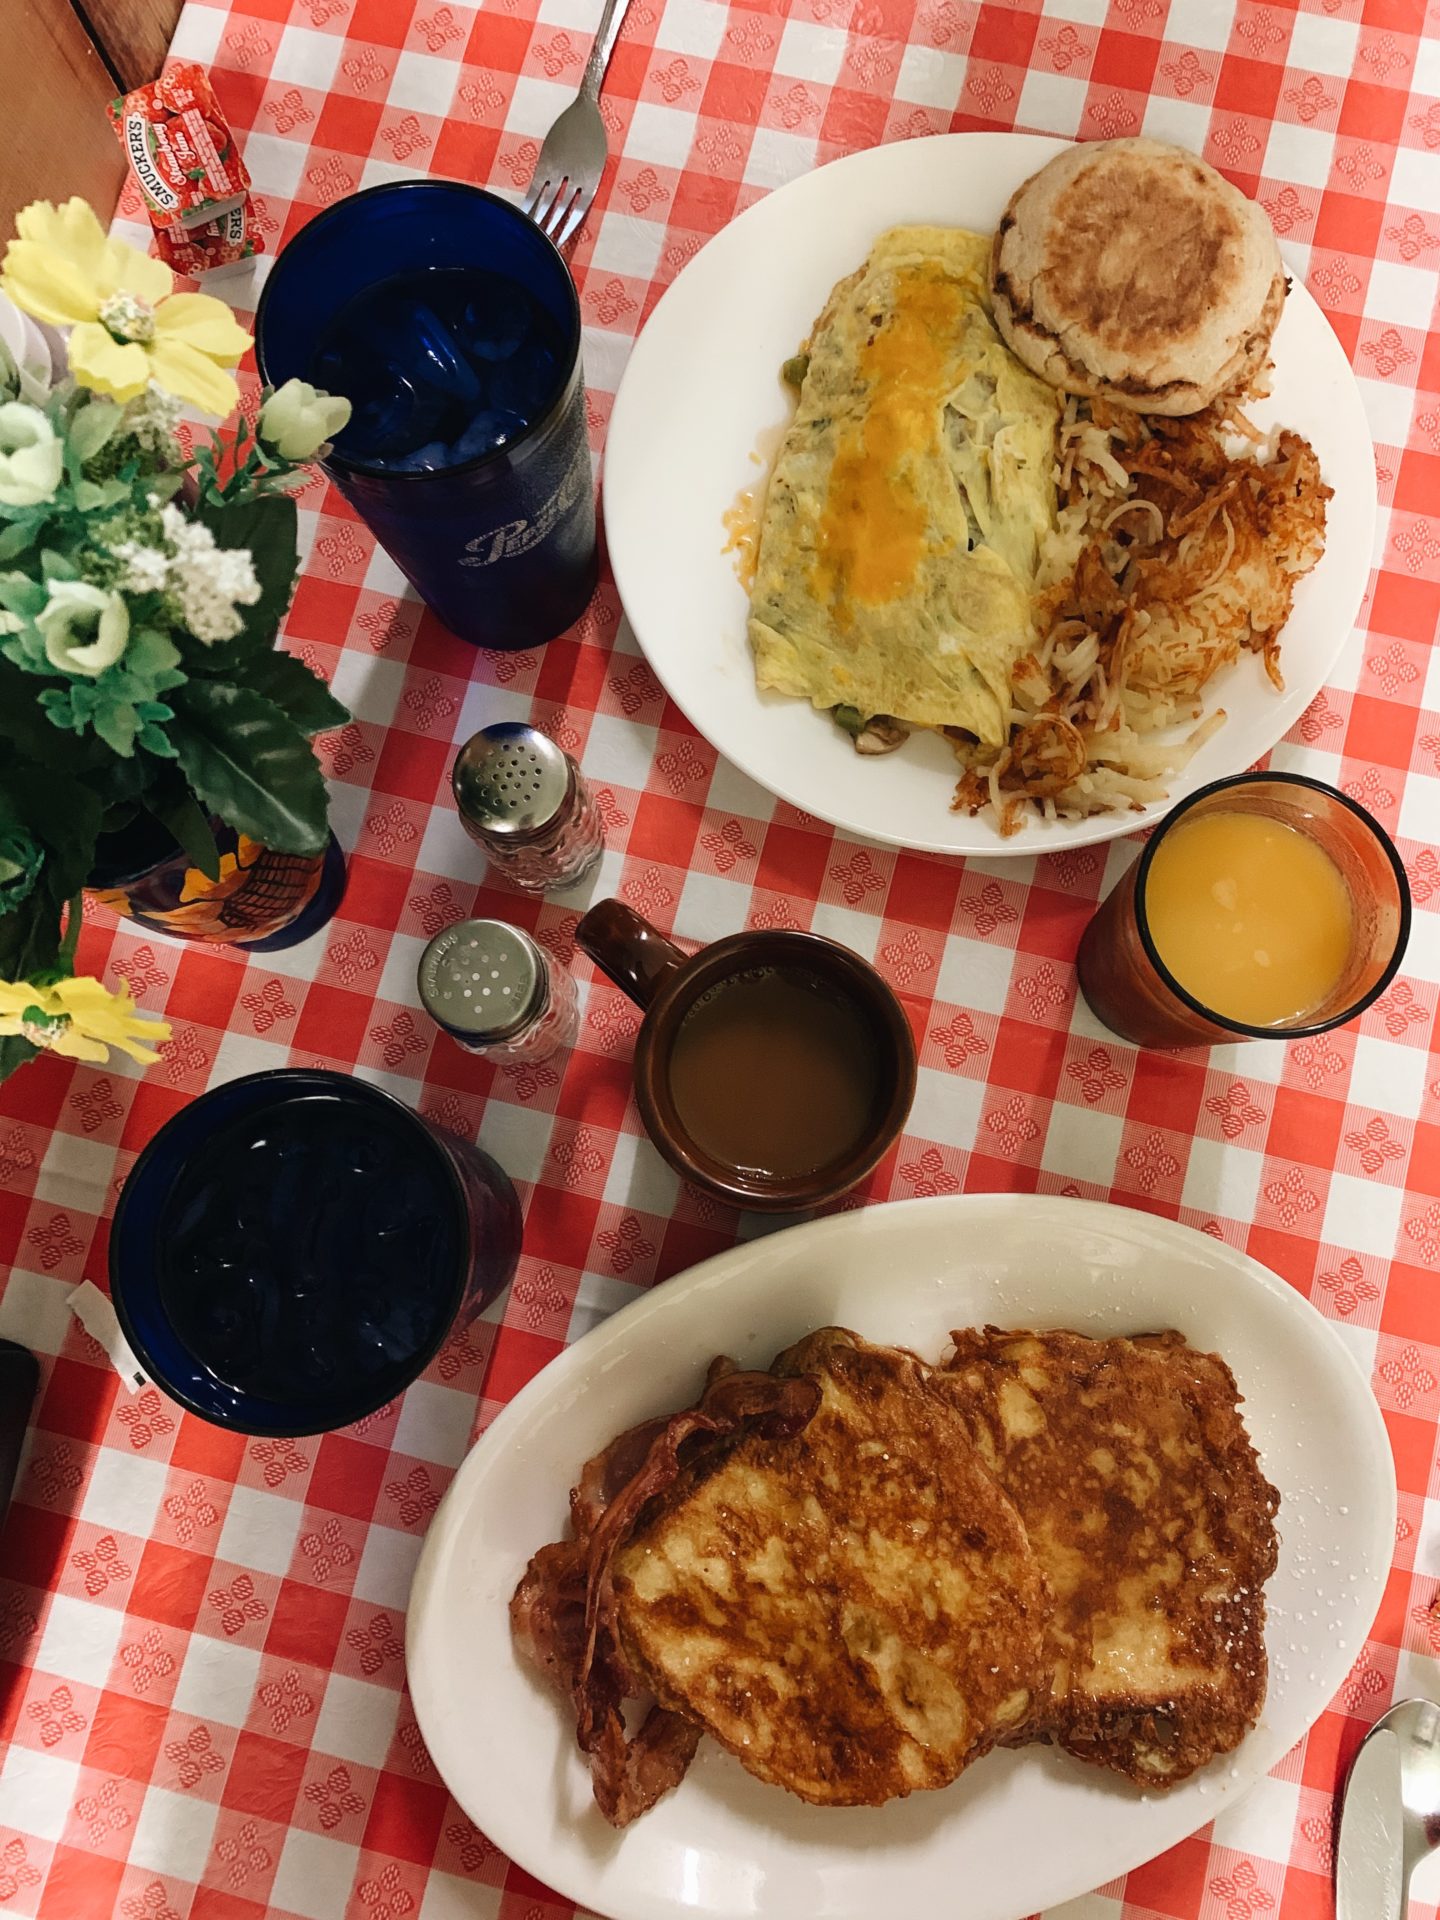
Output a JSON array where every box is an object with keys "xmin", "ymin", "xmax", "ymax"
[{"xmin": 511, "ymin": 1367, "xmax": 820, "ymax": 1826}]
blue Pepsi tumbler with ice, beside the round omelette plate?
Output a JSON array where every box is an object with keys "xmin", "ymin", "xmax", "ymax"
[{"xmin": 255, "ymin": 180, "xmax": 597, "ymax": 649}]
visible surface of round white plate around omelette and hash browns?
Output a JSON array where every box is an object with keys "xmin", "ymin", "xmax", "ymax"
[{"xmin": 603, "ymin": 132, "xmax": 1375, "ymax": 858}]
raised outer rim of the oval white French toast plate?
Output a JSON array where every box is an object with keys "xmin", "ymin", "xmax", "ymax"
[{"xmin": 405, "ymin": 1194, "xmax": 1398, "ymax": 1920}]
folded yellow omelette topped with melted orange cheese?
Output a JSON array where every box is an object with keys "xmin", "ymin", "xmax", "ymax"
[{"xmin": 749, "ymin": 227, "xmax": 1062, "ymax": 745}]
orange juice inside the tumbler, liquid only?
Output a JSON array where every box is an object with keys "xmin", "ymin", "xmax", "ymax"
[{"xmin": 1144, "ymin": 810, "xmax": 1354, "ymax": 1027}]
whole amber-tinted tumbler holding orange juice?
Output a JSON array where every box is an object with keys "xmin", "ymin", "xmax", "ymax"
[{"xmin": 1077, "ymin": 774, "xmax": 1409, "ymax": 1046}]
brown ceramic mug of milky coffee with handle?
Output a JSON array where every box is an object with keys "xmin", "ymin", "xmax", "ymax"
[{"xmin": 576, "ymin": 900, "xmax": 916, "ymax": 1213}]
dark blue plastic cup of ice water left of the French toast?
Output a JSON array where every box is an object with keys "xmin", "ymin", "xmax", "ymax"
[{"xmin": 109, "ymin": 1068, "xmax": 522, "ymax": 1434}]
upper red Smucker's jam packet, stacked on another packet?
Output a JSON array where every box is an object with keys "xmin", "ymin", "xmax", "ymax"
[{"xmin": 109, "ymin": 60, "xmax": 250, "ymax": 232}]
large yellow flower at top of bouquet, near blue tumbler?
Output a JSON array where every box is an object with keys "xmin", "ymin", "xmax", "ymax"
[{"xmin": 0, "ymin": 198, "xmax": 250, "ymax": 415}]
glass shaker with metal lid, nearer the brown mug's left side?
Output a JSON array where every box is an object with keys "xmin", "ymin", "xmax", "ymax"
[{"xmin": 419, "ymin": 920, "xmax": 580, "ymax": 1066}]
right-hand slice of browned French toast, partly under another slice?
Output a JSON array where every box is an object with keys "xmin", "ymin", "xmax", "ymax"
[{"xmin": 948, "ymin": 1327, "xmax": 1279, "ymax": 1788}]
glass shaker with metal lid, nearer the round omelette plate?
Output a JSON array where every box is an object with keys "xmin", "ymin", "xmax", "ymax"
[{"xmin": 451, "ymin": 720, "xmax": 605, "ymax": 893}]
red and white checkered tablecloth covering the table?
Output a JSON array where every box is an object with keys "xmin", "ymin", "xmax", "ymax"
[{"xmin": 0, "ymin": 0, "xmax": 1440, "ymax": 1920}]
